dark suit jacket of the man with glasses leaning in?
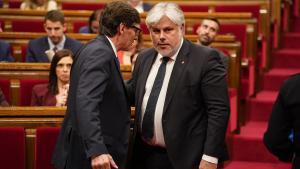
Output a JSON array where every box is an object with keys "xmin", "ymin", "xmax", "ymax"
[{"xmin": 52, "ymin": 36, "xmax": 130, "ymax": 169}]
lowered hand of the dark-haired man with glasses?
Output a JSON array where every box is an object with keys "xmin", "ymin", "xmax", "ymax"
[{"xmin": 91, "ymin": 154, "xmax": 118, "ymax": 169}]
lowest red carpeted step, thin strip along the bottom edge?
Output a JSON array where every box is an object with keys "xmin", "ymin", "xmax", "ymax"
[{"xmin": 224, "ymin": 161, "xmax": 291, "ymax": 169}]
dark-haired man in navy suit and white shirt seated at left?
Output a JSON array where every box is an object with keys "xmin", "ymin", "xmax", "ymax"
[{"xmin": 26, "ymin": 10, "xmax": 82, "ymax": 62}]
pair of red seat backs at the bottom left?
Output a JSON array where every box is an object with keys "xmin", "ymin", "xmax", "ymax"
[{"xmin": 0, "ymin": 127, "xmax": 59, "ymax": 169}]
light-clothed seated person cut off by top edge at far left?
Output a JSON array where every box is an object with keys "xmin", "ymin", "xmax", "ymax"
[{"xmin": 20, "ymin": 0, "xmax": 58, "ymax": 11}]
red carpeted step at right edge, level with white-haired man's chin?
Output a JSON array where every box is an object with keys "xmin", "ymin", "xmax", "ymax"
[{"xmin": 272, "ymin": 49, "xmax": 300, "ymax": 69}]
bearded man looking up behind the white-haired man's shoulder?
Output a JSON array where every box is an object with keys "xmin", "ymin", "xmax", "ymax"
[{"xmin": 196, "ymin": 17, "xmax": 228, "ymax": 69}]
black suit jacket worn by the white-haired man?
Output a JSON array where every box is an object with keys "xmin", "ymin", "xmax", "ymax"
[{"xmin": 127, "ymin": 40, "xmax": 229, "ymax": 169}]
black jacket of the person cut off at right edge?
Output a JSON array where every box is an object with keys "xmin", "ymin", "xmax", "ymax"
[{"xmin": 264, "ymin": 74, "xmax": 300, "ymax": 169}]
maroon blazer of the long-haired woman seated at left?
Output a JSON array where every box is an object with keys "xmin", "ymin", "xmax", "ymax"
[{"xmin": 30, "ymin": 83, "xmax": 56, "ymax": 106}]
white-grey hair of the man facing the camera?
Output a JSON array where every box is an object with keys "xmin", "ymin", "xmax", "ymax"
[{"xmin": 146, "ymin": 2, "xmax": 185, "ymax": 29}]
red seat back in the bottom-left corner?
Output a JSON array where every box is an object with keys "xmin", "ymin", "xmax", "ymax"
[{"xmin": 0, "ymin": 127, "xmax": 26, "ymax": 169}]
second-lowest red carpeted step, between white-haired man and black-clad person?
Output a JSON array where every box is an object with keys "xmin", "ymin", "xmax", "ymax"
[{"xmin": 231, "ymin": 122, "xmax": 278, "ymax": 163}]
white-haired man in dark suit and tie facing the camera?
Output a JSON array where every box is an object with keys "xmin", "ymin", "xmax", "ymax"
[{"xmin": 127, "ymin": 3, "xmax": 229, "ymax": 169}]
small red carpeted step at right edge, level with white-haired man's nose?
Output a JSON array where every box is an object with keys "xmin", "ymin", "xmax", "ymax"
[{"xmin": 280, "ymin": 33, "xmax": 300, "ymax": 49}]
